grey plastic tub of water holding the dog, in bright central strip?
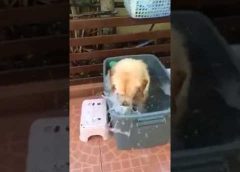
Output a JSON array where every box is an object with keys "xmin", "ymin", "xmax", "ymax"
[{"xmin": 103, "ymin": 54, "xmax": 170, "ymax": 149}]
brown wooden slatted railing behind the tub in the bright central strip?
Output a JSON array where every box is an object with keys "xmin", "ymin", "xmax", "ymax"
[{"xmin": 70, "ymin": 16, "xmax": 170, "ymax": 85}]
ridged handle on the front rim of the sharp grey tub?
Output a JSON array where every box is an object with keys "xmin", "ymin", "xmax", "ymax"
[{"xmin": 137, "ymin": 116, "xmax": 167, "ymax": 127}]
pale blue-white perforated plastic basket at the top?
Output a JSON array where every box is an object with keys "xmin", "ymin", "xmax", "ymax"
[{"xmin": 124, "ymin": 0, "xmax": 171, "ymax": 18}]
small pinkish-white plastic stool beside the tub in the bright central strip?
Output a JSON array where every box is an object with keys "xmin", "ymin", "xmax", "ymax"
[{"xmin": 80, "ymin": 98, "xmax": 109, "ymax": 142}]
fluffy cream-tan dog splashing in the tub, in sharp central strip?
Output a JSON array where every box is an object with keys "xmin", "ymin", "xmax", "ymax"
[{"xmin": 110, "ymin": 58, "xmax": 150, "ymax": 108}]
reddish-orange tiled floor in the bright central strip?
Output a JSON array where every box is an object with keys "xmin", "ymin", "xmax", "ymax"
[{"xmin": 70, "ymin": 98, "xmax": 170, "ymax": 172}]
